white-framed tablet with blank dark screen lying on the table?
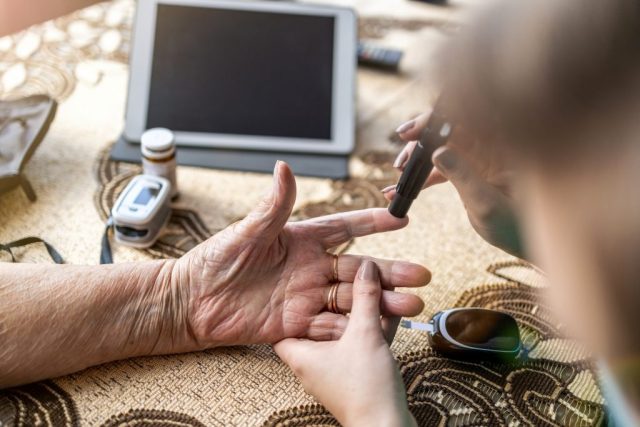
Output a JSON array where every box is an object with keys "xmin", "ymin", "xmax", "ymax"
[{"xmin": 123, "ymin": 0, "xmax": 357, "ymax": 154}]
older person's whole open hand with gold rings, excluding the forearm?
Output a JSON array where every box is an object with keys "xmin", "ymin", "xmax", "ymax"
[{"xmin": 170, "ymin": 162, "xmax": 430, "ymax": 348}]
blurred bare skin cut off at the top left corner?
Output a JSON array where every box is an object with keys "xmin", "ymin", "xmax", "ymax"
[{"xmin": 0, "ymin": 0, "xmax": 100, "ymax": 37}]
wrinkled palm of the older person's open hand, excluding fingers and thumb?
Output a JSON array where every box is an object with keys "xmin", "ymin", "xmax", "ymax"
[{"xmin": 181, "ymin": 227, "xmax": 331, "ymax": 344}]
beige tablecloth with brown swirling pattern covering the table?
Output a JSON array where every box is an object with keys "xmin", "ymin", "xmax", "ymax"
[{"xmin": 0, "ymin": 0, "xmax": 606, "ymax": 426}]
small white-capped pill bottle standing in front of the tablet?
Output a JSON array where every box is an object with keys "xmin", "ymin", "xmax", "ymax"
[{"xmin": 140, "ymin": 128, "xmax": 178, "ymax": 198}]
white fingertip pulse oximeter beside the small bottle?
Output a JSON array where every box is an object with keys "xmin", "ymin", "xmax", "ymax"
[{"xmin": 111, "ymin": 175, "xmax": 171, "ymax": 248}]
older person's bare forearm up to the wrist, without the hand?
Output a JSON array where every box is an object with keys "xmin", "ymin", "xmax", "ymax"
[{"xmin": 0, "ymin": 260, "xmax": 182, "ymax": 387}]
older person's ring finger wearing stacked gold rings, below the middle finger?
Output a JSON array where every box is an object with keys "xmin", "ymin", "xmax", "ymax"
[{"xmin": 323, "ymin": 284, "xmax": 424, "ymax": 317}]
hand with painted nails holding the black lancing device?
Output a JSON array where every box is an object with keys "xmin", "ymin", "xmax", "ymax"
[{"xmin": 382, "ymin": 113, "xmax": 523, "ymax": 257}]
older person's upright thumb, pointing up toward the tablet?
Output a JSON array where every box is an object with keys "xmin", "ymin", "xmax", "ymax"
[{"xmin": 238, "ymin": 160, "xmax": 296, "ymax": 239}]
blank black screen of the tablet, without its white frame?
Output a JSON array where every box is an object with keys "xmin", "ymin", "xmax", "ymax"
[{"xmin": 146, "ymin": 4, "xmax": 335, "ymax": 142}]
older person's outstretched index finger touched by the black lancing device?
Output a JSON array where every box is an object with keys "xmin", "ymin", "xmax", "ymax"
[{"xmin": 292, "ymin": 208, "xmax": 409, "ymax": 249}]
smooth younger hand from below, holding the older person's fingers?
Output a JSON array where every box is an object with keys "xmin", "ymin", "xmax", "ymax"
[{"xmin": 274, "ymin": 260, "xmax": 415, "ymax": 426}]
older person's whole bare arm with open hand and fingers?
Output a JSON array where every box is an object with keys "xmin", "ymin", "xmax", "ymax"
[{"xmin": 0, "ymin": 163, "xmax": 430, "ymax": 387}]
